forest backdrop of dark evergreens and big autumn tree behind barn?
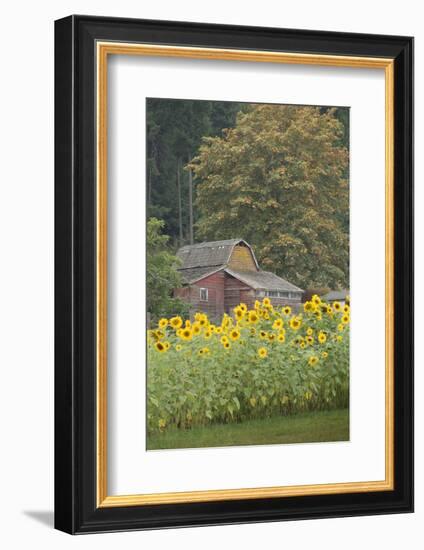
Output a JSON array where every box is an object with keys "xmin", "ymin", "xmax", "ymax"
[{"xmin": 146, "ymin": 98, "xmax": 349, "ymax": 288}]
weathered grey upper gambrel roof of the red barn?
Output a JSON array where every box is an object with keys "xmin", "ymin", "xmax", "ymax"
[{"xmin": 177, "ymin": 239, "xmax": 259, "ymax": 270}]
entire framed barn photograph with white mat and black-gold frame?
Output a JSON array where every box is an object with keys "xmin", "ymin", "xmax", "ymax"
[{"xmin": 55, "ymin": 16, "xmax": 413, "ymax": 534}]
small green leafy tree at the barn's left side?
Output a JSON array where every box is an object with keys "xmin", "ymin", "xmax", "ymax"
[{"xmin": 146, "ymin": 218, "xmax": 187, "ymax": 321}]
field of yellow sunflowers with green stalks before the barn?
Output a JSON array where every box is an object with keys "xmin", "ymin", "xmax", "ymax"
[{"xmin": 147, "ymin": 295, "xmax": 350, "ymax": 434}]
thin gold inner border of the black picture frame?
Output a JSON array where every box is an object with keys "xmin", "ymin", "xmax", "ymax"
[{"xmin": 96, "ymin": 41, "xmax": 394, "ymax": 508}]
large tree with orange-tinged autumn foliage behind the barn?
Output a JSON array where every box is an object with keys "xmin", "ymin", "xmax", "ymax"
[{"xmin": 190, "ymin": 105, "xmax": 349, "ymax": 288}]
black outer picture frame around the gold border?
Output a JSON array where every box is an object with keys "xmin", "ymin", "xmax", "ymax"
[{"xmin": 55, "ymin": 15, "xmax": 413, "ymax": 534}]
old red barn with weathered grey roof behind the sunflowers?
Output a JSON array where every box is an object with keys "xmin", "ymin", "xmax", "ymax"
[{"xmin": 175, "ymin": 239, "xmax": 303, "ymax": 319}]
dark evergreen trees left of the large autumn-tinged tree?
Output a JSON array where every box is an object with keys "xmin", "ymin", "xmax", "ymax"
[{"xmin": 146, "ymin": 98, "xmax": 241, "ymax": 244}]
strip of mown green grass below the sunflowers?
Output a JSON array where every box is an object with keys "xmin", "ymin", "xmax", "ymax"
[{"xmin": 147, "ymin": 409, "xmax": 349, "ymax": 450}]
